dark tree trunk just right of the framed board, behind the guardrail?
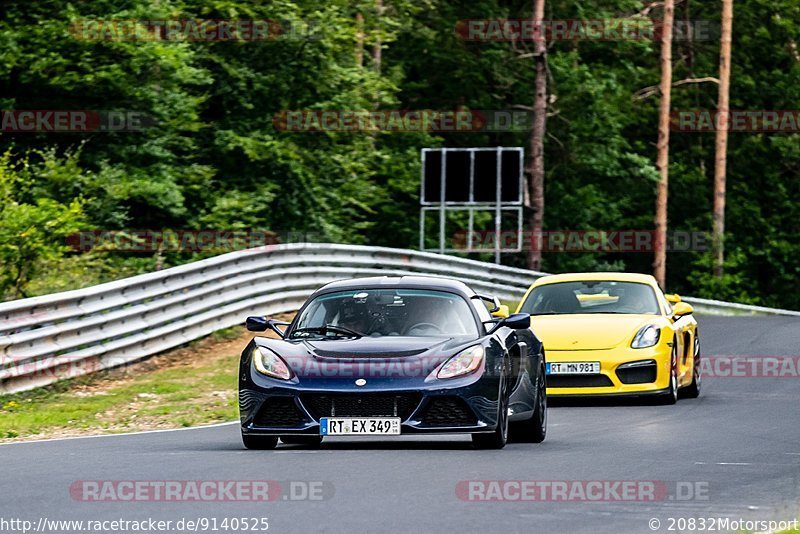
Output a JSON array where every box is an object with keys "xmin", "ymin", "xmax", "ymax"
[{"xmin": 528, "ymin": 0, "xmax": 547, "ymax": 271}]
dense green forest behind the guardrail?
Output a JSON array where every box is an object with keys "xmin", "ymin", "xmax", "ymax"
[{"xmin": 0, "ymin": 0, "xmax": 800, "ymax": 309}]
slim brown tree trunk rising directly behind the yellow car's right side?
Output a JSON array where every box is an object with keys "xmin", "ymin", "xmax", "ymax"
[{"xmin": 653, "ymin": 0, "xmax": 675, "ymax": 288}]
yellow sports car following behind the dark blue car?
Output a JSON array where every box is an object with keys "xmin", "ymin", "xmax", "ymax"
[{"xmin": 517, "ymin": 273, "xmax": 700, "ymax": 404}]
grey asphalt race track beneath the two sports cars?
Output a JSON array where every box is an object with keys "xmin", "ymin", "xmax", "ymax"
[{"xmin": 0, "ymin": 317, "xmax": 800, "ymax": 534}]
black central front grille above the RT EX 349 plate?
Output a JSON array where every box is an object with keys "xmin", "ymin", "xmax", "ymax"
[{"xmin": 300, "ymin": 393, "xmax": 420, "ymax": 420}]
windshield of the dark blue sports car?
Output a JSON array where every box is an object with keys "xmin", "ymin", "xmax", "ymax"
[{"xmin": 290, "ymin": 289, "xmax": 478, "ymax": 338}]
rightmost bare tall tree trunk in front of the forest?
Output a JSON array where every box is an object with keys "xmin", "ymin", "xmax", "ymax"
[{"xmin": 712, "ymin": 0, "xmax": 733, "ymax": 277}]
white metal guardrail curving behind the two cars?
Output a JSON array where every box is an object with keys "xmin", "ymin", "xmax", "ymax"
[{"xmin": 0, "ymin": 244, "xmax": 800, "ymax": 393}]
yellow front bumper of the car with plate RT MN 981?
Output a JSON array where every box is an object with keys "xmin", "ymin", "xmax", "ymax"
[{"xmin": 547, "ymin": 344, "xmax": 671, "ymax": 397}]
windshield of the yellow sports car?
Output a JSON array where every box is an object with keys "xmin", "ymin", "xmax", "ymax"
[{"xmin": 520, "ymin": 280, "xmax": 659, "ymax": 315}]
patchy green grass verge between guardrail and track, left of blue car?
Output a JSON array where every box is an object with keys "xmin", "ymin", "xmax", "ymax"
[{"xmin": 0, "ymin": 327, "xmax": 245, "ymax": 441}]
